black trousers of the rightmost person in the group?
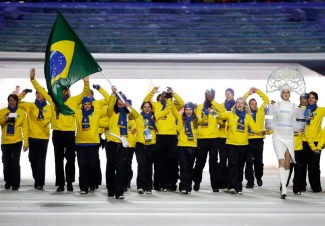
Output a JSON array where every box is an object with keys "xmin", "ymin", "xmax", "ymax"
[{"xmin": 302, "ymin": 141, "xmax": 322, "ymax": 192}]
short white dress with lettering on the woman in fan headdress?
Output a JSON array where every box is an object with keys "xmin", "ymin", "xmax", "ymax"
[{"xmin": 272, "ymin": 101, "xmax": 297, "ymax": 163}]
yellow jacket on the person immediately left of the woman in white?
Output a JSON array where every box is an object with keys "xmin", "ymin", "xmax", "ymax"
[{"xmin": 243, "ymin": 89, "xmax": 270, "ymax": 139}]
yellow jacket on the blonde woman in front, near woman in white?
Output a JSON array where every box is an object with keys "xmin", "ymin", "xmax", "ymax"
[{"xmin": 218, "ymin": 111, "xmax": 261, "ymax": 146}]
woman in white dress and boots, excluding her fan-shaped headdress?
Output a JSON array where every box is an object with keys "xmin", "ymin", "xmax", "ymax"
[{"xmin": 270, "ymin": 84, "xmax": 297, "ymax": 199}]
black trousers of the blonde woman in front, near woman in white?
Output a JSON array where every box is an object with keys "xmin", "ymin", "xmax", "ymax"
[{"xmin": 228, "ymin": 145, "xmax": 247, "ymax": 192}]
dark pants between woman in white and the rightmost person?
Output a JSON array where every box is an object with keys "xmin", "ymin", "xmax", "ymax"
[{"xmin": 293, "ymin": 150, "xmax": 307, "ymax": 193}]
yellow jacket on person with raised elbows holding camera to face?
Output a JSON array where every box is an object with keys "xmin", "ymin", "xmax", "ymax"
[{"xmin": 143, "ymin": 92, "xmax": 185, "ymax": 135}]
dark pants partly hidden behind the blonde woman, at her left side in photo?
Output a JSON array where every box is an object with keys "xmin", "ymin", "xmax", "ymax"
[{"xmin": 217, "ymin": 138, "xmax": 228, "ymax": 189}]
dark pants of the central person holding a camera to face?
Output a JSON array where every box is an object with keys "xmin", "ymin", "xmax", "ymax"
[{"xmin": 156, "ymin": 135, "xmax": 179, "ymax": 189}]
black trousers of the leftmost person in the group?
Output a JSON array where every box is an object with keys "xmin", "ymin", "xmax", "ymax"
[{"xmin": 1, "ymin": 141, "xmax": 23, "ymax": 188}]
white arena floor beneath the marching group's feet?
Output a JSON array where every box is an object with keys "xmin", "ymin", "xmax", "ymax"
[{"xmin": 0, "ymin": 165, "xmax": 325, "ymax": 226}]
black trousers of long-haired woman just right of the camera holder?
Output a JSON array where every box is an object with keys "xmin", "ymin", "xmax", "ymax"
[{"xmin": 178, "ymin": 147, "xmax": 197, "ymax": 191}]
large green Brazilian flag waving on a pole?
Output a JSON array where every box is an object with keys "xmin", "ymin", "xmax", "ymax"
[{"xmin": 44, "ymin": 13, "xmax": 102, "ymax": 115}]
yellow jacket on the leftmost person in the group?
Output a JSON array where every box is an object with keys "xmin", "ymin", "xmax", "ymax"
[{"xmin": 0, "ymin": 105, "xmax": 29, "ymax": 147}]
